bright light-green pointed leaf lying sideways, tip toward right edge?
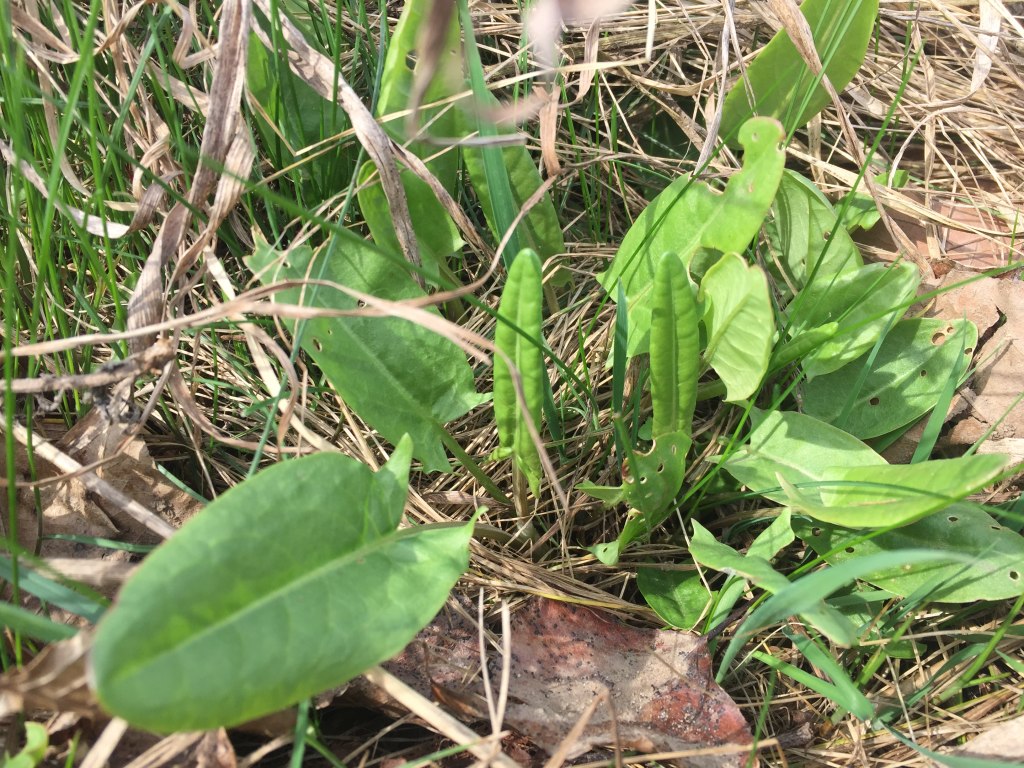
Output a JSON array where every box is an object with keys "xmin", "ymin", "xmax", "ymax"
[{"xmin": 779, "ymin": 454, "xmax": 1010, "ymax": 528}]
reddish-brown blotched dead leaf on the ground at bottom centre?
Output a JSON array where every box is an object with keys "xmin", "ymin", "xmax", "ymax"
[{"xmin": 360, "ymin": 599, "xmax": 752, "ymax": 767}]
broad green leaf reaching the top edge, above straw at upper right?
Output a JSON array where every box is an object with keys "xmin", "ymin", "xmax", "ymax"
[{"xmin": 720, "ymin": 0, "xmax": 879, "ymax": 140}]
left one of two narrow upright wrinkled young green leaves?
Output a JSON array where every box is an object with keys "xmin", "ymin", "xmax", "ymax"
[{"xmin": 495, "ymin": 250, "xmax": 547, "ymax": 496}]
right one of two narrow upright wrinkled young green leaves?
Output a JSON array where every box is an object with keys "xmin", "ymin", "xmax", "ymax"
[{"xmin": 650, "ymin": 253, "xmax": 700, "ymax": 440}]
